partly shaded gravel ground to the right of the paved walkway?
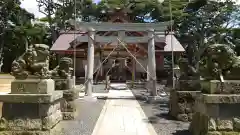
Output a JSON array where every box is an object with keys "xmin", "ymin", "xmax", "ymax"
[{"xmin": 132, "ymin": 89, "xmax": 191, "ymax": 135}]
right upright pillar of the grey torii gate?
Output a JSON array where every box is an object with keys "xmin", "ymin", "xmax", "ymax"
[{"xmin": 148, "ymin": 29, "xmax": 157, "ymax": 96}]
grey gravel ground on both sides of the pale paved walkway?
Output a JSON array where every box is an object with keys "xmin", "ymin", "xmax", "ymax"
[{"xmin": 53, "ymin": 86, "xmax": 191, "ymax": 135}]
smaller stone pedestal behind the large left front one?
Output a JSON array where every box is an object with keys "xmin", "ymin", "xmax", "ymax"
[{"xmin": 55, "ymin": 79, "xmax": 79, "ymax": 120}]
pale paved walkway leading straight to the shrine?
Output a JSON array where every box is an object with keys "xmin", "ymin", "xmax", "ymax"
[{"xmin": 92, "ymin": 90, "xmax": 157, "ymax": 135}]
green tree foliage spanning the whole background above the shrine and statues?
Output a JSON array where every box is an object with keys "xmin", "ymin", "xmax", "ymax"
[{"xmin": 0, "ymin": 0, "xmax": 240, "ymax": 74}]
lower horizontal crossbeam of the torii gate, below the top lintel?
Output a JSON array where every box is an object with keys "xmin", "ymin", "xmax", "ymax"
[{"xmin": 77, "ymin": 35, "xmax": 165, "ymax": 44}]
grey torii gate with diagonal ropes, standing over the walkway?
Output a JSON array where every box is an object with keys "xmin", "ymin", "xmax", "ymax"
[{"xmin": 68, "ymin": 21, "xmax": 170, "ymax": 96}]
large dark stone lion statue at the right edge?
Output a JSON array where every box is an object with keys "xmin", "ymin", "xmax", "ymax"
[{"xmin": 200, "ymin": 44, "xmax": 240, "ymax": 81}]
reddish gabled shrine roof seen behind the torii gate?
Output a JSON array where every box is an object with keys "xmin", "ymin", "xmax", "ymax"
[{"xmin": 51, "ymin": 8, "xmax": 185, "ymax": 53}]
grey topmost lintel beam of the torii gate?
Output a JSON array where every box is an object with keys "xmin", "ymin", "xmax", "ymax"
[{"xmin": 70, "ymin": 20, "xmax": 173, "ymax": 31}]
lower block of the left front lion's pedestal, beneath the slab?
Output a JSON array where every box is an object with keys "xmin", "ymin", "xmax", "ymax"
[{"xmin": 0, "ymin": 102, "xmax": 62, "ymax": 135}]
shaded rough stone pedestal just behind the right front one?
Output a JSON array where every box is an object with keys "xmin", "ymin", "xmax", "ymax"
[{"xmin": 169, "ymin": 80, "xmax": 201, "ymax": 122}]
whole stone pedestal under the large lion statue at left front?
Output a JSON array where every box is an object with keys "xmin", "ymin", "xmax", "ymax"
[{"xmin": 0, "ymin": 79, "xmax": 63, "ymax": 135}]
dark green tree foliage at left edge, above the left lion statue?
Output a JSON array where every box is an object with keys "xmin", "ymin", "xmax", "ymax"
[{"xmin": 0, "ymin": 0, "xmax": 49, "ymax": 72}]
